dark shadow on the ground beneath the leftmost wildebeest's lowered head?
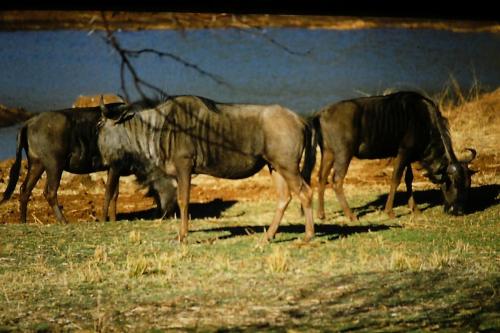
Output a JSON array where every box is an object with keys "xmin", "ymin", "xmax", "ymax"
[{"xmin": 117, "ymin": 198, "xmax": 238, "ymax": 220}]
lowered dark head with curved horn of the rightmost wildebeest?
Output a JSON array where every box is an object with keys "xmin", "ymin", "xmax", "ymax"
[{"xmin": 441, "ymin": 148, "xmax": 476, "ymax": 215}]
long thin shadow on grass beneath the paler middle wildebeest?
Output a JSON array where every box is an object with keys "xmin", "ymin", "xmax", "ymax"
[{"xmin": 197, "ymin": 224, "xmax": 401, "ymax": 243}]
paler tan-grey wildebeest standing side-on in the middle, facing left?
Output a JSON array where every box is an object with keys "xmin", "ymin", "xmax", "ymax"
[{"xmin": 99, "ymin": 96, "xmax": 314, "ymax": 241}]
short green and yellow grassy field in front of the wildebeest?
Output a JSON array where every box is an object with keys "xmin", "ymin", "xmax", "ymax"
[{"xmin": 0, "ymin": 186, "xmax": 500, "ymax": 332}]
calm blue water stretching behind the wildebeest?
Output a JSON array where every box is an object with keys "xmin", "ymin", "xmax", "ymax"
[{"xmin": 0, "ymin": 28, "xmax": 500, "ymax": 159}]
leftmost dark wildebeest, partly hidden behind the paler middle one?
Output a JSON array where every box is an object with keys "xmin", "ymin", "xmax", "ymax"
[{"xmin": 0, "ymin": 103, "xmax": 175, "ymax": 223}]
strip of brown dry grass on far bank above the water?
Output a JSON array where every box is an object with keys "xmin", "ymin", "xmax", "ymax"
[{"xmin": 0, "ymin": 10, "xmax": 500, "ymax": 32}]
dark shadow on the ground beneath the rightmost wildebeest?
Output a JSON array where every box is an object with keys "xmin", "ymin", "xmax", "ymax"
[{"xmin": 353, "ymin": 184, "xmax": 500, "ymax": 217}]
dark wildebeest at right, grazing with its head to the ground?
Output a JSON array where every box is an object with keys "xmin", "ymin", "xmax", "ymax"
[{"xmin": 312, "ymin": 92, "xmax": 476, "ymax": 221}]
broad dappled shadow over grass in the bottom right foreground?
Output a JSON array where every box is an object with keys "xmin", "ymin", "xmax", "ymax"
[{"xmin": 218, "ymin": 270, "xmax": 500, "ymax": 332}]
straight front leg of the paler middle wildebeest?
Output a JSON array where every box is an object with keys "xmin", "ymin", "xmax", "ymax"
[{"xmin": 175, "ymin": 159, "xmax": 192, "ymax": 242}]
